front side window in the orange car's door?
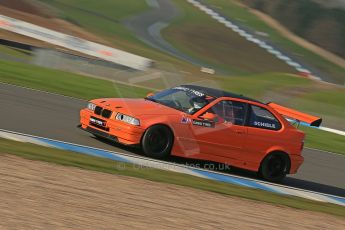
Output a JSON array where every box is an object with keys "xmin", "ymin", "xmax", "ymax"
[{"xmin": 203, "ymin": 100, "xmax": 246, "ymax": 125}]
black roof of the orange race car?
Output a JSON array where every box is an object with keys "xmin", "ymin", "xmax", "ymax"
[{"xmin": 181, "ymin": 85, "xmax": 265, "ymax": 104}]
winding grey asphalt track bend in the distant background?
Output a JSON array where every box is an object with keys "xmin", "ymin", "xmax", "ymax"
[{"xmin": 123, "ymin": 0, "xmax": 203, "ymax": 66}]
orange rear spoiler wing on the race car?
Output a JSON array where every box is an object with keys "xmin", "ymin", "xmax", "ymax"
[{"xmin": 267, "ymin": 102, "xmax": 322, "ymax": 127}]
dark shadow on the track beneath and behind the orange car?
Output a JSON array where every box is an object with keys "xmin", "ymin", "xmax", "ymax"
[{"xmin": 94, "ymin": 137, "xmax": 345, "ymax": 197}]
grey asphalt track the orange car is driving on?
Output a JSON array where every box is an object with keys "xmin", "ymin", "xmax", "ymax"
[{"xmin": 0, "ymin": 84, "xmax": 345, "ymax": 197}]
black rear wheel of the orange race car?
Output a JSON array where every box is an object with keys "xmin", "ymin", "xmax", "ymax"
[{"xmin": 259, "ymin": 152, "xmax": 290, "ymax": 182}]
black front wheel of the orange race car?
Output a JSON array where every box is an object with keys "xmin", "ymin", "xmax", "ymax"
[{"xmin": 141, "ymin": 125, "xmax": 173, "ymax": 159}]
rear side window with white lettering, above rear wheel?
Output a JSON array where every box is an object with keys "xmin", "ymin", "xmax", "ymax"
[{"xmin": 248, "ymin": 105, "xmax": 281, "ymax": 130}]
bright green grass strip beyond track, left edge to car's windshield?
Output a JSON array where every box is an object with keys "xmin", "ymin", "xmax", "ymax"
[{"xmin": 0, "ymin": 60, "xmax": 148, "ymax": 100}]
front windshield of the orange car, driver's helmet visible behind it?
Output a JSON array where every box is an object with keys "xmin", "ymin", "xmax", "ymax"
[{"xmin": 146, "ymin": 86, "xmax": 215, "ymax": 114}]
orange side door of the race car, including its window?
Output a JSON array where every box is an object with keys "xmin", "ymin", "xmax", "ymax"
[{"xmin": 192, "ymin": 100, "xmax": 247, "ymax": 159}]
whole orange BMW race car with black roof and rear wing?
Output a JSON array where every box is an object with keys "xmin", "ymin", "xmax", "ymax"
[{"xmin": 80, "ymin": 85, "xmax": 322, "ymax": 181}]
